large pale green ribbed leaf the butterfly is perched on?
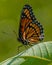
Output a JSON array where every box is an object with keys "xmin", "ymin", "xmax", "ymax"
[{"xmin": 0, "ymin": 41, "xmax": 52, "ymax": 65}]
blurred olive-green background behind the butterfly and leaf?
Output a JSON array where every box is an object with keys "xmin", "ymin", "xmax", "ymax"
[{"xmin": 0, "ymin": 0, "xmax": 52, "ymax": 62}]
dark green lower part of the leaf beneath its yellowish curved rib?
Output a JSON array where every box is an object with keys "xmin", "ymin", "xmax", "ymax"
[{"xmin": 21, "ymin": 57, "xmax": 51, "ymax": 65}]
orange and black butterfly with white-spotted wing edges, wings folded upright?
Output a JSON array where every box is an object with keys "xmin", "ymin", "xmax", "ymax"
[{"xmin": 18, "ymin": 4, "xmax": 44, "ymax": 45}]
